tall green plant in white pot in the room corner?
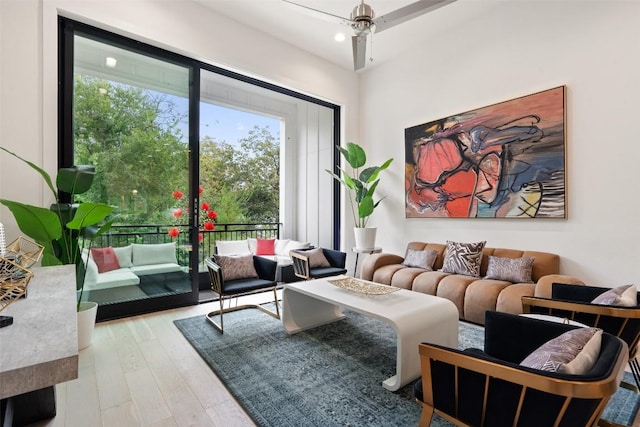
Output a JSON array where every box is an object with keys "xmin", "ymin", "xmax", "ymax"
[{"xmin": 326, "ymin": 142, "xmax": 393, "ymax": 249}]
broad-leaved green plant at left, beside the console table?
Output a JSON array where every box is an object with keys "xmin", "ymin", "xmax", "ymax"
[{"xmin": 0, "ymin": 147, "xmax": 113, "ymax": 306}]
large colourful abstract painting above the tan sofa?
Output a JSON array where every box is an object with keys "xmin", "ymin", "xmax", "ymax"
[{"xmin": 405, "ymin": 86, "xmax": 566, "ymax": 218}]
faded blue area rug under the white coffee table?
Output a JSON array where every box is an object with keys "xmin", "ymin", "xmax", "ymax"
[{"xmin": 174, "ymin": 310, "xmax": 640, "ymax": 427}]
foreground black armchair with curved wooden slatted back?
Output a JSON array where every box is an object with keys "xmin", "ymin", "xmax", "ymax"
[{"xmin": 414, "ymin": 311, "xmax": 628, "ymax": 427}]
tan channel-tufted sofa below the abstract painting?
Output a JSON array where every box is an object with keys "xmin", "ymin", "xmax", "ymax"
[{"xmin": 361, "ymin": 242, "xmax": 584, "ymax": 324}]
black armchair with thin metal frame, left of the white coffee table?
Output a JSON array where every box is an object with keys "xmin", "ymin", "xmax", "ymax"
[{"xmin": 205, "ymin": 255, "xmax": 280, "ymax": 333}]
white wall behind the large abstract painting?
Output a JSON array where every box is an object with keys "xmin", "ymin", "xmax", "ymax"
[{"xmin": 360, "ymin": 0, "xmax": 640, "ymax": 286}]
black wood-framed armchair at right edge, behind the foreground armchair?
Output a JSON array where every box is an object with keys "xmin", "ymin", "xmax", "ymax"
[{"xmin": 522, "ymin": 283, "xmax": 640, "ymax": 392}]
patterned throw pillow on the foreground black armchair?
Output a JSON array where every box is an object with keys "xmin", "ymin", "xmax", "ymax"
[{"xmin": 520, "ymin": 328, "xmax": 602, "ymax": 375}]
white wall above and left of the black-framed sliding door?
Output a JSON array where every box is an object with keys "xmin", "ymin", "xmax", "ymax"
[{"xmin": 0, "ymin": 0, "xmax": 358, "ymax": 254}]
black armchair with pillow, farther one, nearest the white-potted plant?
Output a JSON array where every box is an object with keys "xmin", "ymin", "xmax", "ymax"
[{"xmin": 289, "ymin": 248, "xmax": 347, "ymax": 280}]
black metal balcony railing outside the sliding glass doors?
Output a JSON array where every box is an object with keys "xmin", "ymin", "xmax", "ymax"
[{"xmin": 94, "ymin": 222, "xmax": 282, "ymax": 265}]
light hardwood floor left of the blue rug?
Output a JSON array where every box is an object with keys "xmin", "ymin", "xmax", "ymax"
[{"xmin": 32, "ymin": 299, "xmax": 264, "ymax": 427}]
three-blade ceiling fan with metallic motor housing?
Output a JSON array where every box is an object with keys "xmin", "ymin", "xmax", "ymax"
[{"xmin": 282, "ymin": 0, "xmax": 456, "ymax": 70}]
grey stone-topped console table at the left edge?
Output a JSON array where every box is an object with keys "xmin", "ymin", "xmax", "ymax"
[{"xmin": 0, "ymin": 265, "xmax": 78, "ymax": 425}]
